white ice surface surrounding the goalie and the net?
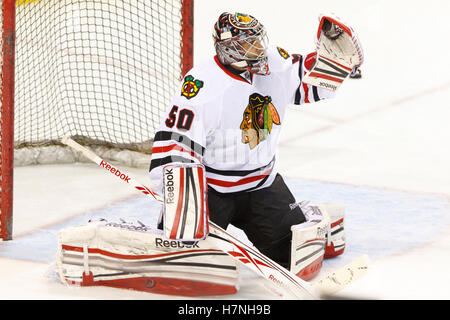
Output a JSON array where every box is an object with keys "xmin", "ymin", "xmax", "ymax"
[{"xmin": 0, "ymin": 0, "xmax": 450, "ymax": 299}]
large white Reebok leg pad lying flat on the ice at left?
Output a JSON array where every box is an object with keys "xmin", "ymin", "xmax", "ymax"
[{"xmin": 55, "ymin": 220, "xmax": 239, "ymax": 296}]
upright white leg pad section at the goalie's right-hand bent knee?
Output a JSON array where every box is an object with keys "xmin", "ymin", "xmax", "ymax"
[{"xmin": 290, "ymin": 205, "xmax": 330, "ymax": 280}]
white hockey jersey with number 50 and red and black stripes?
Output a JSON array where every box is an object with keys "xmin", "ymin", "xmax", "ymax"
[{"xmin": 150, "ymin": 47, "xmax": 334, "ymax": 193}]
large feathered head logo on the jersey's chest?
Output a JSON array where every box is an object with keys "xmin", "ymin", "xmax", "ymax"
[{"xmin": 240, "ymin": 93, "xmax": 281, "ymax": 149}]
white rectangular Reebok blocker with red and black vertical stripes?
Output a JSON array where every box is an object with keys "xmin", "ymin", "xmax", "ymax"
[{"xmin": 163, "ymin": 164, "xmax": 209, "ymax": 241}]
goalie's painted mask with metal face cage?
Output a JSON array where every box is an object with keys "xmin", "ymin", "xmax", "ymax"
[{"xmin": 213, "ymin": 12, "xmax": 269, "ymax": 75}]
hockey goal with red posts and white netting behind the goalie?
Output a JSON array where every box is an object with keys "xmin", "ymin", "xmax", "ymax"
[{"xmin": 0, "ymin": 0, "xmax": 194, "ymax": 240}]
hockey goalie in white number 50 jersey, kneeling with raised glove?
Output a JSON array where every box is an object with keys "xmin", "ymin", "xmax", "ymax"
[{"xmin": 57, "ymin": 12, "xmax": 364, "ymax": 296}]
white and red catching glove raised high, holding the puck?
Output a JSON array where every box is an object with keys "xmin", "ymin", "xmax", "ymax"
[{"xmin": 303, "ymin": 15, "xmax": 364, "ymax": 91}]
